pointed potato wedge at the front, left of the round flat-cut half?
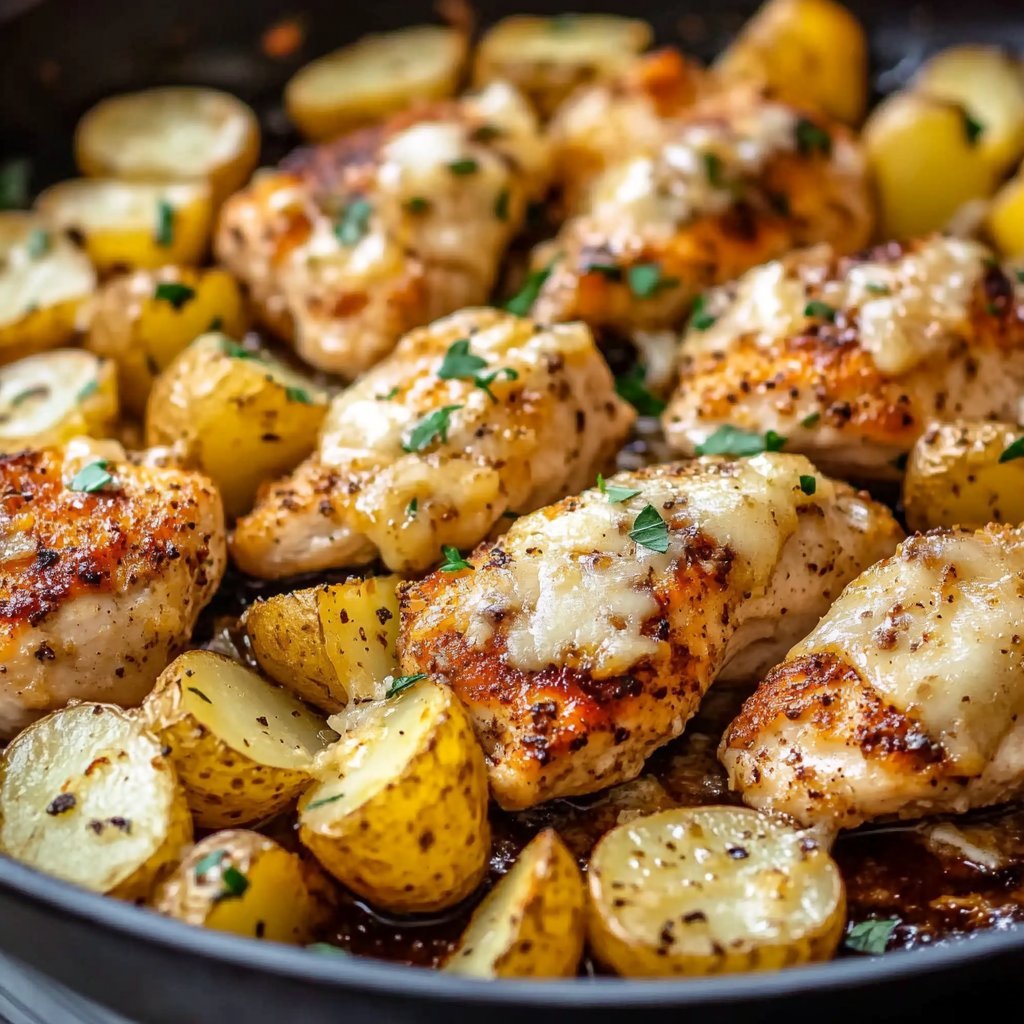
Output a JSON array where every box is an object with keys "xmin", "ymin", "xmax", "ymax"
[{"xmin": 444, "ymin": 828, "xmax": 587, "ymax": 978}]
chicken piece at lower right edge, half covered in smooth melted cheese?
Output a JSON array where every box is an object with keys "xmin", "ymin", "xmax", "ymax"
[{"xmin": 719, "ymin": 526, "xmax": 1024, "ymax": 830}]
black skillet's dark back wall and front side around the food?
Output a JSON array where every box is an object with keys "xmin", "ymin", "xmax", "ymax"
[{"xmin": 0, "ymin": 0, "xmax": 1024, "ymax": 1024}]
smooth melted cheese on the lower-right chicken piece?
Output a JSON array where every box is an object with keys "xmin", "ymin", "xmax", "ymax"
[{"xmin": 790, "ymin": 529, "xmax": 1024, "ymax": 775}]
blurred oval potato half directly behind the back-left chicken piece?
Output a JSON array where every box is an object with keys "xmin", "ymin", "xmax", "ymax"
[{"xmin": 285, "ymin": 25, "xmax": 466, "ymax": 141}]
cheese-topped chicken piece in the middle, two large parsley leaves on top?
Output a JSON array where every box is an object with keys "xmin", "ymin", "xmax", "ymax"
[{"xmin": 231, "ymin": 308, "xmax": 634, "ymax": 577}]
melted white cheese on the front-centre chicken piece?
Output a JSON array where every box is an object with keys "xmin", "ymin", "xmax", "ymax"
[{"xmin": 463, "ymin": 455, "xmax": 835, "ymax": 678}]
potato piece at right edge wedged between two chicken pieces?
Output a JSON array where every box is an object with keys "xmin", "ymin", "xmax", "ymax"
[{"xmin": 903, "ymin": 422, "xmax": 1024, "ymax": 530}]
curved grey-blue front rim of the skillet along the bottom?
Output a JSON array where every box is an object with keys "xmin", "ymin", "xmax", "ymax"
[{"xmin": 0, "ymin": 854, "xmax": 1024, "ymax": 1010}]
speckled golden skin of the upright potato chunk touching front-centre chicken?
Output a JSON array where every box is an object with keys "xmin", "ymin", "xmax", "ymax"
[{"xmin": 299, "ymin": 682, "xmax": 490, "ymax": 913}]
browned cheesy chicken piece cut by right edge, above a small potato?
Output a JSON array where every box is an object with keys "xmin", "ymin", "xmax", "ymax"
[{"xmin": 664, "ymin": 237, "xmax": 1024, "ymax": 479}]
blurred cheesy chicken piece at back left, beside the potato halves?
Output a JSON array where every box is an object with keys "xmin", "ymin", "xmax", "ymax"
[{"xmin": 216, "ymin": 83, "xmax": 548, "ymax": 377}]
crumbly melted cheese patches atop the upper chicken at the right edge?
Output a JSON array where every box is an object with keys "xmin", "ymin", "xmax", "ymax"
[{"xmin": 685, "ymin": 238, "xmax": 987, "ymax": 375}]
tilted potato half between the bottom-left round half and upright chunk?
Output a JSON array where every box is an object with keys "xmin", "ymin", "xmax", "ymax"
[{"xmin": 142, "ymin": 650, "xmax": 336, "ymax": 828}]
